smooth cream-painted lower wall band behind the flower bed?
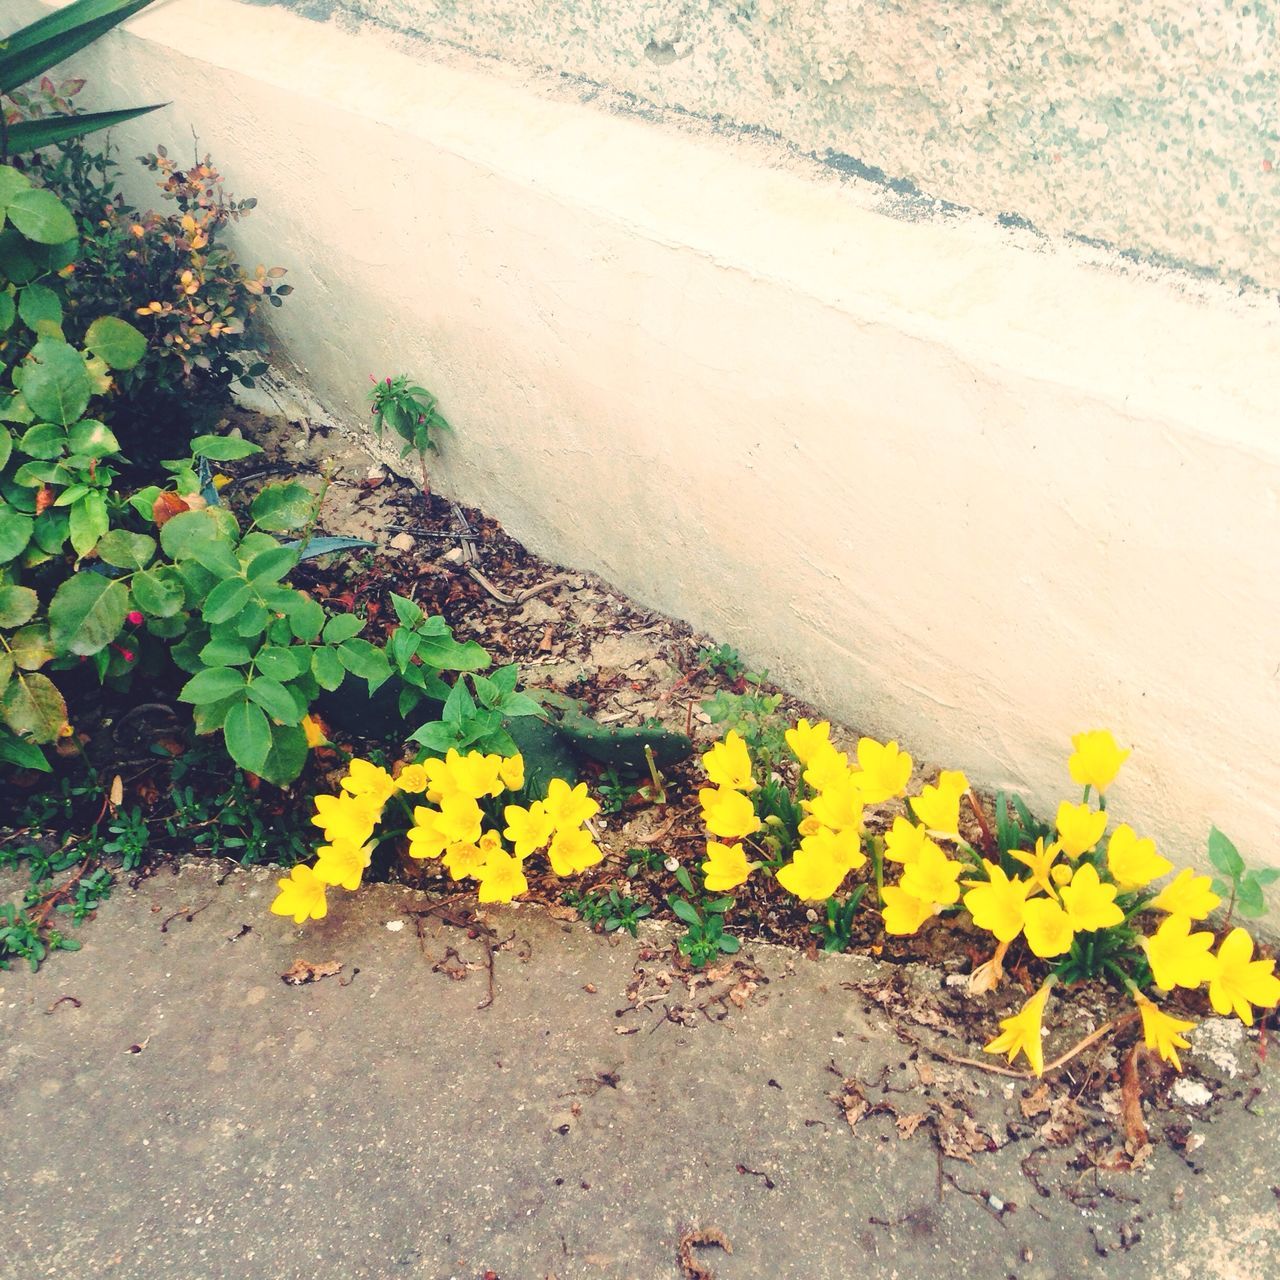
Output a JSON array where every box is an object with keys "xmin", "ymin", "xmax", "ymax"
[{"xmin": 17, "ymin": 0, "xmax": 1280, "ymax": 896}]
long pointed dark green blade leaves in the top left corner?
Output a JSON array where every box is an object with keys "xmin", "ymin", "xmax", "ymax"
[{"xmin": 0, "ymin": 0, "xmax": 160, "ymax": 160}]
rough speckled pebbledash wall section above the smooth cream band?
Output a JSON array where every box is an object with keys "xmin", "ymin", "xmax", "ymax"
[{"xmin": 252, "ymin": 0, "xmax": 1280, "ymax": 287}]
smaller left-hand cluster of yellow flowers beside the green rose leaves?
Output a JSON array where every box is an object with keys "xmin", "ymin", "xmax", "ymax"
[{"xmin": 271, "ymin": 750, "xmax": 602, "ymax": 924}]
